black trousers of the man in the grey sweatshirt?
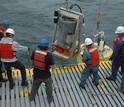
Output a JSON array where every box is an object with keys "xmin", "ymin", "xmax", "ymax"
[{"xmin": 3, "ymin": 61, "xmax": 26, "ymax": 83}]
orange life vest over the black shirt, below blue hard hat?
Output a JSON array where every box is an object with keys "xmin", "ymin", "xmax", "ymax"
[{"xmin": 33, "ymin": 49, "xmax": 48, "ymax": 70}]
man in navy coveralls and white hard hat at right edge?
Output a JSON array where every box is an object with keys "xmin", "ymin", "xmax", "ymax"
[{"xmin": 106, "ymin": 26, "xmax": 124, "ymax": 81}]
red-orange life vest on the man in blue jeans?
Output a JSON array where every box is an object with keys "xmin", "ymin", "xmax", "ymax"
[{"xmin": 88, "ymin": 47, "xmax": 100, "ymax": 66}]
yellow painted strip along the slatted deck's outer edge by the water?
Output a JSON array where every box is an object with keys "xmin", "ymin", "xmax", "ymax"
[{"xmin": 2, "ymin": 61, "xmax": 111, "ymax": 79}]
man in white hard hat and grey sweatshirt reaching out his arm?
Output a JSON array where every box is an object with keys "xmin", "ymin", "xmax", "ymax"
[{"xmin": 0, "ymin": 28, "xmax": 28, "ymax": 89}]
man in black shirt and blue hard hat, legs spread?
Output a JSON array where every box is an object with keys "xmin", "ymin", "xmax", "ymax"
[{"xmin": 29, "ymin": 39, "xmax": 55, "ymax": 103}]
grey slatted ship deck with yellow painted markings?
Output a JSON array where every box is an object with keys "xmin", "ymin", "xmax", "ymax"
[{"xmin": 0, "ymin": 61, "xmax": 124, "ymax": 107}]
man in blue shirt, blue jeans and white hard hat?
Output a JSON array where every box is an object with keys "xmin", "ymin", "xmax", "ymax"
[{"xmin": 79, "ymin": 38, "xmax": 100, "ymax": 89}]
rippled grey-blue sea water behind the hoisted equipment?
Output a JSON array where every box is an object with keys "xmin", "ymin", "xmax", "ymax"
[{"xmin": 0, "ymin": 0, "xmax": 124, "ymax": 66}]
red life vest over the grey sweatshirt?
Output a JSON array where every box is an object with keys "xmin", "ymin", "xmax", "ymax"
[{"xmin": 0, "ymin": 43, "xmax": 15, "ymax": 59}]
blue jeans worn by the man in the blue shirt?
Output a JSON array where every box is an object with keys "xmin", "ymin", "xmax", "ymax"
[{"xmin": 80, "ymin": 66, "xmax": 99, "ymax": 87}]
